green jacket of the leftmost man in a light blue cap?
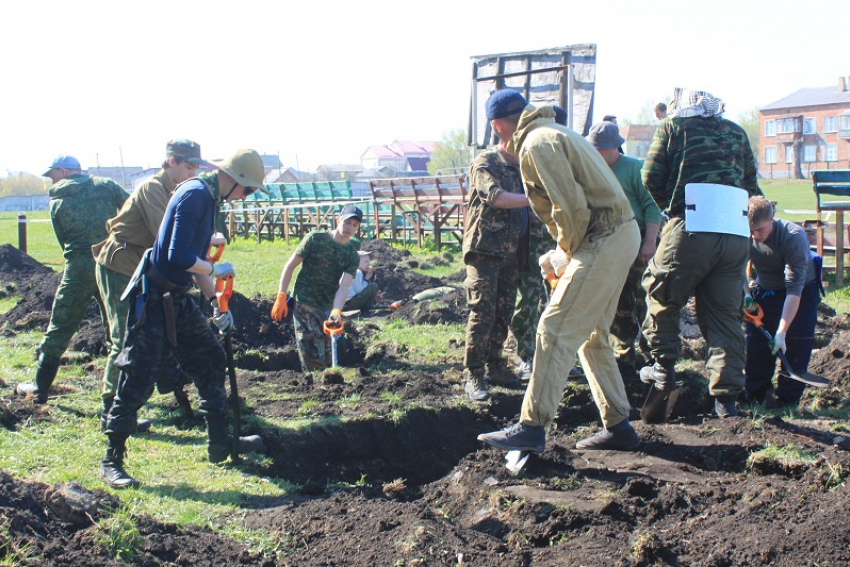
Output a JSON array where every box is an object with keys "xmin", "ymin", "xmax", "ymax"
[{"xmin": 48, "ymin": 174, "xmax": 129, "ymax": 258}]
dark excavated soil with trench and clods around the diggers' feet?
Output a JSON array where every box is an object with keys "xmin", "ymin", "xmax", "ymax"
[{"xmin": 0, "ymin": 242, "xmax": 850, "ymax": 567}]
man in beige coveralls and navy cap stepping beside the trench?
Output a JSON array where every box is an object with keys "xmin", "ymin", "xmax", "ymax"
[{"xmin": 478, "ymin": 90, "xmax": 640, "ymax": 452}]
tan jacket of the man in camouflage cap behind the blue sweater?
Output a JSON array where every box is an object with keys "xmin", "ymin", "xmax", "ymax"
[{"xmin": 92, "ymin": 169, "xmax": 176, "ymax": 276}]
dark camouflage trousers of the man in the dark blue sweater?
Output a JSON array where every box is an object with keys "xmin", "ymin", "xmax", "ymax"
[{"xmin": 106, "ymin": 280, "xmax": 228, "ymax": 436}]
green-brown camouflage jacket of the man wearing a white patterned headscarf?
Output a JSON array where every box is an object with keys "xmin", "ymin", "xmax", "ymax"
[{"xmin": 641, "ymin": 116, "xmax": 762, "ymax": 217}]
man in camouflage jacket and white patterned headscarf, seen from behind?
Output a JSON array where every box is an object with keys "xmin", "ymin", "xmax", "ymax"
[{"xmin": 640, "ymin": 89, "xmax": 762, "ymax": 417}]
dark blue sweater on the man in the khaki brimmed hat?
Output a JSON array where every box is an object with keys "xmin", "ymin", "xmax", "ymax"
[{"xmin": 152, "ymin": 178, "xmax": 216, "ymax": 286}]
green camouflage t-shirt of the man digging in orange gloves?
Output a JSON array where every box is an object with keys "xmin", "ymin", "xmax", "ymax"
[{"xmin": 292, "ymin": 230, "xmax": 360, "ymax": 310}]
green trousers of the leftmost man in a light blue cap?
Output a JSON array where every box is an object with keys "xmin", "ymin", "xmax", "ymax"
[{"xmin": 39, "ymin": 254, "xmax": 106, "ymax": 364}]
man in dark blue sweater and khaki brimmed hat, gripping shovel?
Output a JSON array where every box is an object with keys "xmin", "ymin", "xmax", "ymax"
[{"xmin": 100, "ymin": 150, "xmax": 264, "ymax": 488}]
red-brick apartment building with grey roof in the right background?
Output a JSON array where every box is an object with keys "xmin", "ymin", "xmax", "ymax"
[{"xmin": 759, "ymin": 77, "xmax": 850, "ymax": 179}]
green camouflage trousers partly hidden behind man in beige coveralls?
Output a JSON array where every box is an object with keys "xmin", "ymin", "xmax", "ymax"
[{"xmin": 510, "ymin": 226, "xmax": 555, "ymax": 360}]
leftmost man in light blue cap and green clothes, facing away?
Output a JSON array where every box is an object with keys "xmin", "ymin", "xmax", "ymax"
[{"xmin": 16, "ymin": 155, "xmax": 129, "ymax": 404}]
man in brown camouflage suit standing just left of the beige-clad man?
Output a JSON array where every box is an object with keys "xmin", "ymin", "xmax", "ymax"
[{"xmin": 463, "ymin": 93, "xmax": 528, "ymax": 401}]
